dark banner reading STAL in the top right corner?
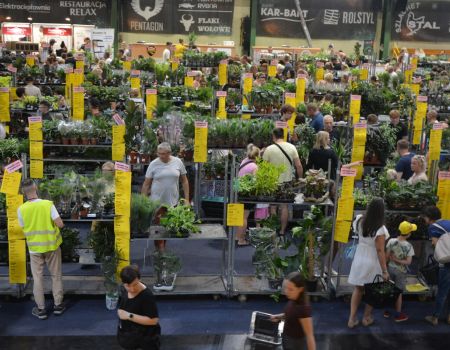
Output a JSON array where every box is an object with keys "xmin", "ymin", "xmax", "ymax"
[{"xmin": 391, "ymin": 0, "xmax": 450, "ymax": 42}]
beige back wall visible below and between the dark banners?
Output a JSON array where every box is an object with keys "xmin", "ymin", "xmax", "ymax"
[{"xmin": 120, "ymin": 0, "xmax": 450, "ymax": 54}]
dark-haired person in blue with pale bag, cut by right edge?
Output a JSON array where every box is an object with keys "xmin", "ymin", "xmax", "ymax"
[{"xmin": 422, "ymin": 206, "xmax": 450, "ymax": 326}]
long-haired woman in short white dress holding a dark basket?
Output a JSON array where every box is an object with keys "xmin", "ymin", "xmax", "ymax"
[{"xmin": 348, "ymin": 198, "xmax": 389, "ymax": 328}]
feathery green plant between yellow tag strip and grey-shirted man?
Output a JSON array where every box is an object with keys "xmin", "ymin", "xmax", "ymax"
[{"xmin": 130, "ymin": 193, "xmax": 160, "ymax": 237}]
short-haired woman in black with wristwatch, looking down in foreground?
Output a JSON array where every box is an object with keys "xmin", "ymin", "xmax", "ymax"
[{"xmin": 117, "ymin": 266, "xmax": 161, "ymax": 350}]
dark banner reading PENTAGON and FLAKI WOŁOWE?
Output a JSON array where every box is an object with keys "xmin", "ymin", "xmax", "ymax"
[{"xmin": 121, "ymin": 0, "xmax": 234, "ymax": 36}]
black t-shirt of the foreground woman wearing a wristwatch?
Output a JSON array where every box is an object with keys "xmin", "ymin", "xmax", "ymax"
[{"xmin": 119, "ymin": 288, "xmax": 161, "ymax": 336}]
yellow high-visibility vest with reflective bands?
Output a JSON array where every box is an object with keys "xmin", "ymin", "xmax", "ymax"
[{"xmin": 19, "ymin": 200, "xmax": 62, "ymax": 253}]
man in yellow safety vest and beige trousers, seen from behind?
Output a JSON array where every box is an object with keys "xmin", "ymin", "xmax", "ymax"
[{"xmin": 17, "ymin": 179, "xmax": 65, "ymax": 320}]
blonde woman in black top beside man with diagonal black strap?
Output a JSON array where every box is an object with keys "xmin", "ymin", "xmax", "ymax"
[{"xmin": 306, "ymin": 131, "xmax": 338, "ymax": 180}]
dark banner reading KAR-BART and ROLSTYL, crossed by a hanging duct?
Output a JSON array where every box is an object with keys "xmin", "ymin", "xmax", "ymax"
[{"xmin": 256, "ymin": 0, "xmax": 379, "ymax": 40}]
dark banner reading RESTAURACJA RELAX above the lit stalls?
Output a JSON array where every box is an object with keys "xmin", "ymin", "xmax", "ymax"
[{"xmin": 0, "ymin": 0, "xmax": 111, "ymax": 26}]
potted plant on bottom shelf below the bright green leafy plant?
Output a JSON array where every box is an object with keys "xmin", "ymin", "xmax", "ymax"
[{"xmin": 152, "ymin": 250, "xmax": 181, "ymax": 292}]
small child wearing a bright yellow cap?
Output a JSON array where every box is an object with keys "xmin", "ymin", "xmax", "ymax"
[{"xmin": 384, "ymin": 221, "xmax": 417, "ymax": 322}]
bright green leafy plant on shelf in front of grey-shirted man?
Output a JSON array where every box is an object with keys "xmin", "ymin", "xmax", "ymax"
[{"xmin": 160, "ymin": 200, "xmax": 200, "ymax": 237}]
